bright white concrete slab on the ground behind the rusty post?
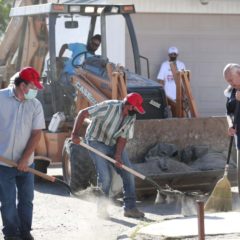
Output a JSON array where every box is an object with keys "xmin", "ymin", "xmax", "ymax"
[{"xmin": 130, "ymin": 212, "xmax": 240, "ymax": 239}]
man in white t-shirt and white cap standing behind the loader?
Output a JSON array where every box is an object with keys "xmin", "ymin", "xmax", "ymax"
[{"xmin": 157, "ymin": 47, "xmax": 186, "ymax": 101}]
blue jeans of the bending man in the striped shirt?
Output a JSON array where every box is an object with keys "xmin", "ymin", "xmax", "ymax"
[{"xmin": 89, "ymin": 141, "xmax": 136, "ymax": 210}]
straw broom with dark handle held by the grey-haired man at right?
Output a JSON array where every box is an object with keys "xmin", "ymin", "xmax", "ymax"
[{"xmin": 204, "ymin": 136, "xmax": 233, "ymax": 212}]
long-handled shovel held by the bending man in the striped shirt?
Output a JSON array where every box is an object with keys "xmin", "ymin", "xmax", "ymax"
[{"xmin": 80, "ymin": 141, "xmax": 183, "ymax": 203}]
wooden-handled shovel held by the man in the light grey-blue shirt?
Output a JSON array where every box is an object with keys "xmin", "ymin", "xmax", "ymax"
[{"xmin": 0, "ymin": 156, "xmax": 75, "ymax": 195}]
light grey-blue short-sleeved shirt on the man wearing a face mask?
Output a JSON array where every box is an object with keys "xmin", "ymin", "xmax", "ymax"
[{"xmin": 0, "ymin": 87, "xmax": 45, "ymax": 165}]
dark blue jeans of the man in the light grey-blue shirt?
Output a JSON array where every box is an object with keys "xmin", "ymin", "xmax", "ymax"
[{"xmin": 0, "ymin": 165, "xmax": 34, "ymax": 237}]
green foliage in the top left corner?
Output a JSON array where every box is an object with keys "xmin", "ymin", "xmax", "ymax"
[{"xmin": 0, "ymin": 0, "xmax": 13, "ymax": 36}]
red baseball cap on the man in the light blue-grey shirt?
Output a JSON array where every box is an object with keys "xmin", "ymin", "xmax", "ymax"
[{"xmin": 19, "ymin": 67, "xmax": 43, "ymax": 89}]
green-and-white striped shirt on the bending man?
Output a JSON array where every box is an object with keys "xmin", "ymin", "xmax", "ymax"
[{"xmin": 85, "ymin": 100, "xmax": 136, "ymax": 146}]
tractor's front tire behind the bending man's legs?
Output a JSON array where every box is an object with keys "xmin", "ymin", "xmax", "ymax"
[{"xmin": 62, "ymin": 138, "xmax": 97, "ymax": 192}]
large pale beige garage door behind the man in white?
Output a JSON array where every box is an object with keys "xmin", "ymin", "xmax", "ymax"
[{"xmin": 126, "ymin": 14, "xmax": 240, "ymax": 116}]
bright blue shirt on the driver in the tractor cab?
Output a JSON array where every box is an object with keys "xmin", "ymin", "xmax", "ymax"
[{"xmin": 64, "ymin": 43, "xmax": 93, "ymax": 75}]
